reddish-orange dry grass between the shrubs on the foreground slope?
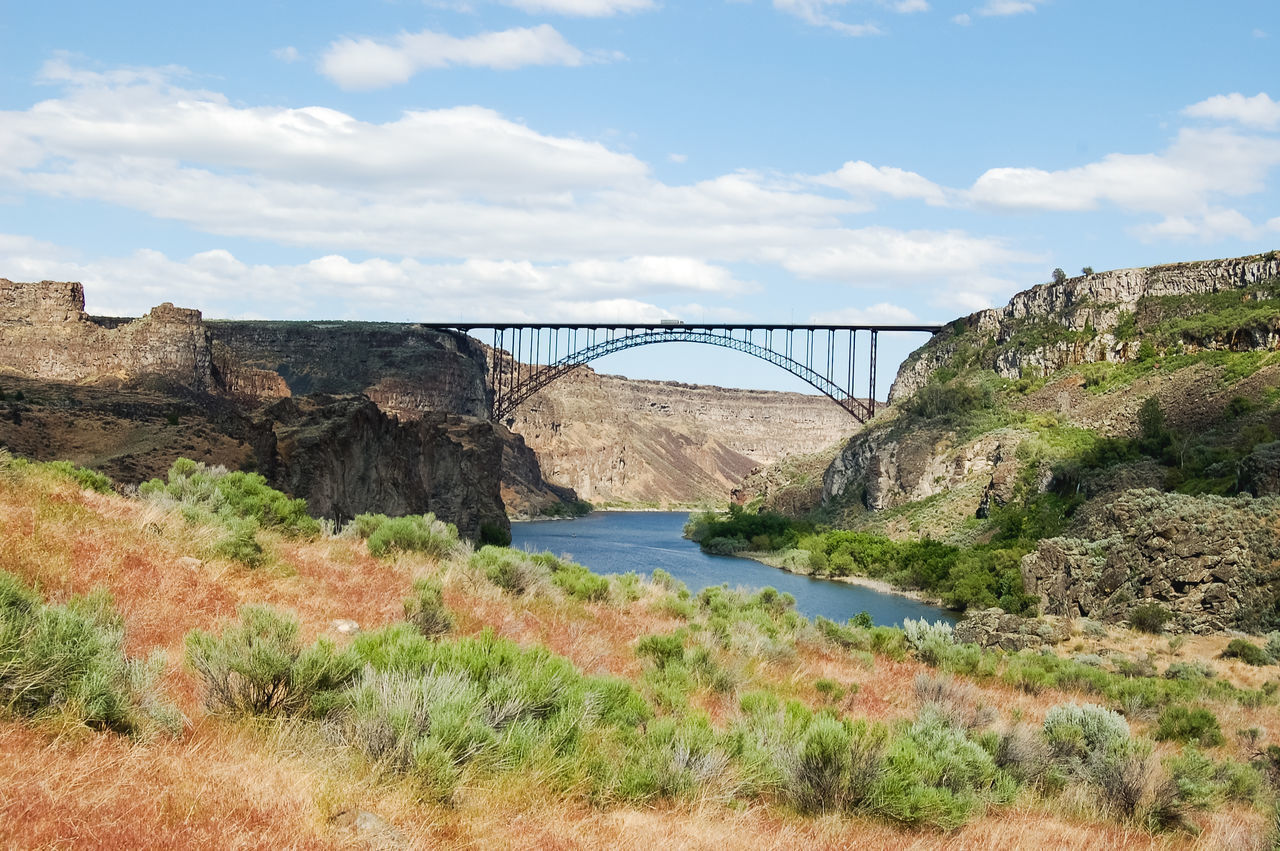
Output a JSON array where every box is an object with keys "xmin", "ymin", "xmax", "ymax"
[{"xmin": 0, "ymin": 471, "xmax": 1280, "ymax": 851}]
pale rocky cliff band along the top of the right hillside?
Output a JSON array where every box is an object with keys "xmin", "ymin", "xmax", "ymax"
[{"xmin": 890, "ymin": 252, "xmax": 1280, "ymax": 402}]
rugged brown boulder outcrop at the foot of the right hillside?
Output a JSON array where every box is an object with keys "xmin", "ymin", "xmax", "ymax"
[{"xmin": 1021, "ymin": 489, "xmax": 1280, "ymax": 632}]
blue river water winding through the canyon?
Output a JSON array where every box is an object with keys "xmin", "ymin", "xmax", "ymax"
[{"xmin": 511, "ymin": 511, "xmax": 956, "ymax": 624}]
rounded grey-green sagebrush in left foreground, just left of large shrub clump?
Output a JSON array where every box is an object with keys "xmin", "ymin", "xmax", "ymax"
[{"xmin": 187, "ymin": 605, "xmax": 360, "ymax": 715}]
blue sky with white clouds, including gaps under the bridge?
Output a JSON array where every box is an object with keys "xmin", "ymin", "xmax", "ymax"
[{"xmin": 0, "ymin": 0, "xmax": 1280, "ymax": 395}]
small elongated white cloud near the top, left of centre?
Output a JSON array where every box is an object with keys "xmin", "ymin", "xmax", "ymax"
[{"xmin": 320, "ymin": 24, "xmax": 588, "ymax": 90}]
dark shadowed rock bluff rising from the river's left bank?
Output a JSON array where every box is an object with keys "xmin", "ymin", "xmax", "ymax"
[{"xmin": 257, "ymin": 394, "xmax": 509, "ymax": 540}]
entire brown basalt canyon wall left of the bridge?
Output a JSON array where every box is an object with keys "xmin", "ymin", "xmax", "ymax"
[{"xmin": 0, "ymin": 279, "xmax": 509, "ymax": 537}]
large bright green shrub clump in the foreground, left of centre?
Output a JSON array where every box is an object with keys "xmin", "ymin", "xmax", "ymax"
[{"xmin": 338, "ymin": 624, "xmax": 650, "ymax": 799}]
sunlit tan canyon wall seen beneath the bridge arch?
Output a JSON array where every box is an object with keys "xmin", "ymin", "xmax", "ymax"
[{"xmin": 509, "ymin": 367, "xmax": 859, "ymax": 504}]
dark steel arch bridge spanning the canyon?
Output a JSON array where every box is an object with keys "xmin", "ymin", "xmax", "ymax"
[{"xmin": 421, "ymin": 320, "xmax": 943, "ymax": 422}]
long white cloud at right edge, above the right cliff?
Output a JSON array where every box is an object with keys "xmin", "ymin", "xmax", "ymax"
[{"xmin": 969, "ymin": 129, "xmax": 1280, "ymax": 214}]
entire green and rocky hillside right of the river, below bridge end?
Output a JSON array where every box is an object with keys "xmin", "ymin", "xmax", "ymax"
[{"xmin": 692, "ymin": 252, "xmax": 1280, "ymax": 633}]
